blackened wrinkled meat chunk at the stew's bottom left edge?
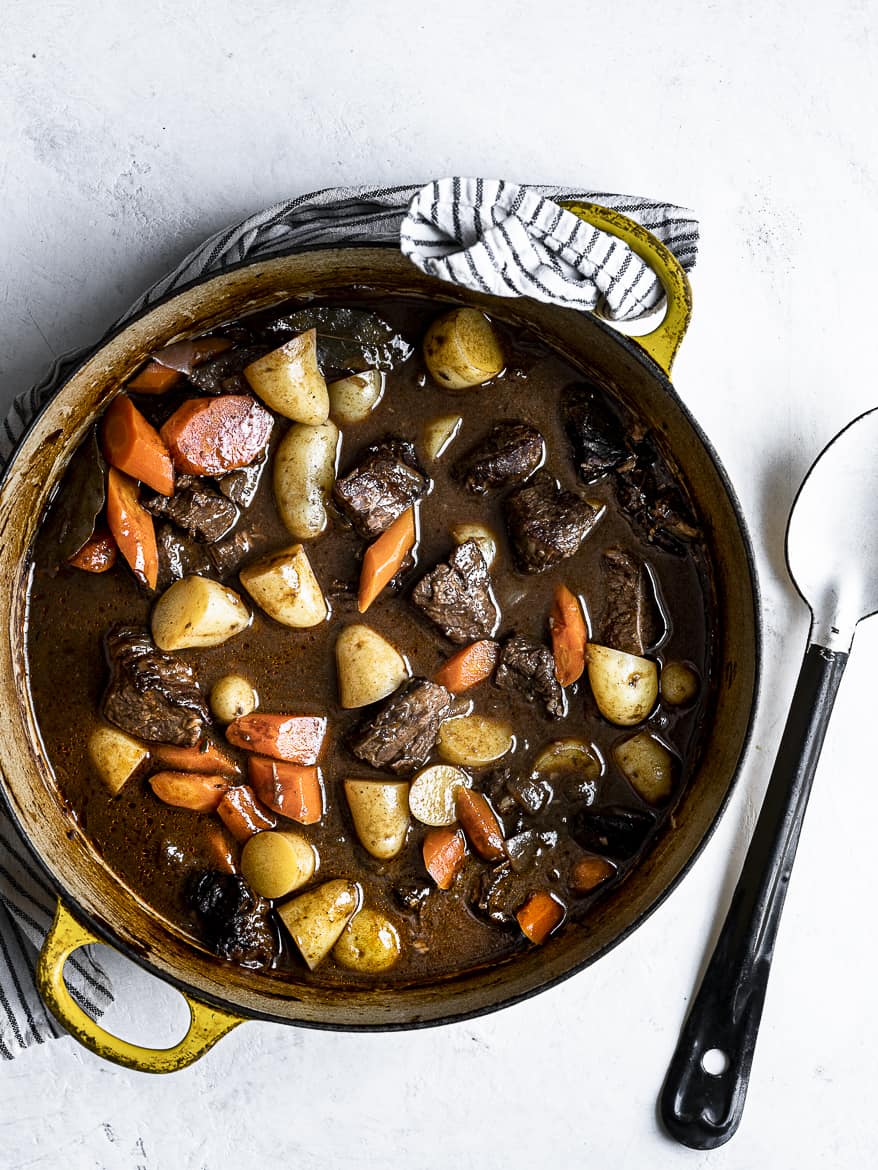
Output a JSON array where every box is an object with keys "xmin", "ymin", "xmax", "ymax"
[{"xmin": 188, "ymin": 869, "xmax": 277, "ymax": 968}]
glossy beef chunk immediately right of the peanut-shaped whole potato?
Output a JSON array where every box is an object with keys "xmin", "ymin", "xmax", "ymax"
[{"xmin": 332, "ymin": 435, "xmax": 430, "ymax": 541}]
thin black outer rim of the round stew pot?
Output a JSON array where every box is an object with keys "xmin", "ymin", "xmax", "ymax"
[{"xmin": 0, "ymin": 241, "xmax": 763, "ymax": 1032}]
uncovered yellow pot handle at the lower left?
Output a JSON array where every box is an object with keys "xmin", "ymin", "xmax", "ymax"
[{"xmin": 36, "ymin": 902, "xmax": 243, "ymax": 1073}]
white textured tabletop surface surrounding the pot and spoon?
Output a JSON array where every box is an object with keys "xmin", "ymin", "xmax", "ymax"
[{"xmin": 0, "ymin": 0, "xmax": 878, "ymax": 1170}]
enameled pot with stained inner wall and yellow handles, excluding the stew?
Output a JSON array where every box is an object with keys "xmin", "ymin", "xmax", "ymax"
[{"xmin": 0, "ymin": 205, "xmax": 760, "ymax": 1072}]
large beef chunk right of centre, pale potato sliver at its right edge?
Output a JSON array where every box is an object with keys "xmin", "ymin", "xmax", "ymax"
[{"xmin": 505, "ymin": 472, "xmax": 601, "ymax": 573}]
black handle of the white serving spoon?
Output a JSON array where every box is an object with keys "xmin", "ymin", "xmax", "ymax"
[{"xmin": 660, "ymin": 644, "xmax": 848, "ymax": 1150}]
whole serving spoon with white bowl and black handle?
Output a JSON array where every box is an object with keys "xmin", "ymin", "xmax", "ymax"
[{"xmin": 659, "ymin": 408, "xmax": 878, "ymax": 1150}]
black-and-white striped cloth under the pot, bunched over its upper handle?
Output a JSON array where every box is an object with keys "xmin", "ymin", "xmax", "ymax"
[{"xmin": 0, "ymin": 178, "xmax": 698, "ymax": 1059}]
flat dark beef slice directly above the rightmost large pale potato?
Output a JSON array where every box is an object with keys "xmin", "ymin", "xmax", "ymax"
[{"xmin": 601, "ymin": 549, "xmax": 665, "ymax": 654}]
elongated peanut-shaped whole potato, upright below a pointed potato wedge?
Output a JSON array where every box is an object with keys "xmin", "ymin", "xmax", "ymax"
[{"xmin": 274, "ymin": 422, "xmax": 338, "ymax": 541}]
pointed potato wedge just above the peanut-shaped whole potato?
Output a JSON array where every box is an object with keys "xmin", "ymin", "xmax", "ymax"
[{"xmin": 243, "ymin": 329, "xmax": 329, "ymax": 426}]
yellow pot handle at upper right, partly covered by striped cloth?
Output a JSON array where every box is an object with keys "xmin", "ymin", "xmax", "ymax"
[{"xmin": 561, "ymin": 202, "xmax": 692, "ymax": 374}]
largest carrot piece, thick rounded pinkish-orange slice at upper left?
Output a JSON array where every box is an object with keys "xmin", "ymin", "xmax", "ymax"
[{"xmin": 160, "ymin": 394, "xmax": 274, "ymax": 475}]
